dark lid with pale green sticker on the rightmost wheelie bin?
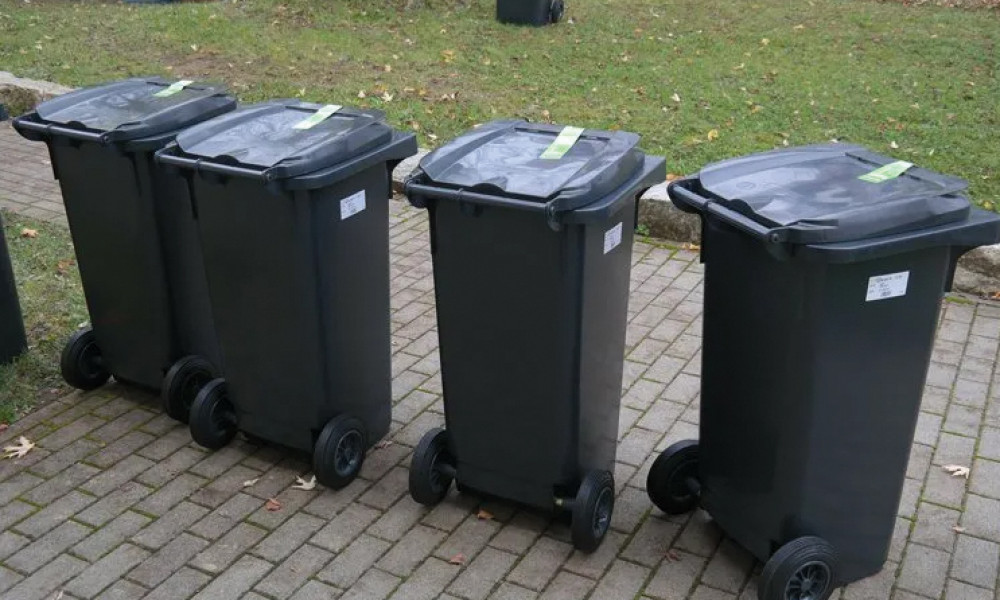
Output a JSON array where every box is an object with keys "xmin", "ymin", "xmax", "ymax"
[{"xmin": 698, "ymin": 143, "xmax": 970, "ymax": 243}]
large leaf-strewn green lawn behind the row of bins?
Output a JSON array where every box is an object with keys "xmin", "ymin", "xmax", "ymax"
[{"xmin": 0, "ymin": 0, "xmax": 1000, "ymax": 207}]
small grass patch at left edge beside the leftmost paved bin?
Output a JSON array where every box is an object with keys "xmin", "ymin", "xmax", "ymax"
[{"xmin": 0, "ymin": 212, "xmax": 87, "ymax": 423}]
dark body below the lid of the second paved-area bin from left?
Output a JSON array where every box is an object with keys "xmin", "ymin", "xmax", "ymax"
[{"xmin": 193, "ymin": 164, "xmax": 391, "ymax": 450}]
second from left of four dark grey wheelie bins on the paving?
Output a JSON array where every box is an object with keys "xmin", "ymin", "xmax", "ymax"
[{"xmin": 157, "ymin": 100, "xmax": 417, "ymax": 488}]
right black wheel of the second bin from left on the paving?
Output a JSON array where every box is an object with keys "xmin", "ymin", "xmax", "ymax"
[{"xmin": 313, "ymin": 415, "xmax": 368, "ymax": 490}]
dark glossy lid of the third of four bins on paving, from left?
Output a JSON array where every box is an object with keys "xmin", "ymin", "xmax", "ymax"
[{"xmin": 412, "ymin": 120, "xmax": 645, "ymax": 205}]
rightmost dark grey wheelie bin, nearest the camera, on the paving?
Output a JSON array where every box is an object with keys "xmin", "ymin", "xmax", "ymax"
[{"xmin": 647, "ymin": 144, "xmax": 1000, "ymax": 600}]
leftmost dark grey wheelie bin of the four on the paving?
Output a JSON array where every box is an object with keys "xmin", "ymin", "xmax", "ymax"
[{"xmin": 14, "ymin": 78, "xmax": 236, "ymax": 412}]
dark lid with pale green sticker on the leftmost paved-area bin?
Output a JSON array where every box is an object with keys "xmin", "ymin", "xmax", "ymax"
[{"xmin": 35, "ymin": 77, "xmax": 236, "ymax": 142}]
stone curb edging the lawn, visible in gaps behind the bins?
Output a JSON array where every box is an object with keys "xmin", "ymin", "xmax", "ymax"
[{"xmin": 7, "ymin": 71, "xmax": 1000, "ymax": 296}]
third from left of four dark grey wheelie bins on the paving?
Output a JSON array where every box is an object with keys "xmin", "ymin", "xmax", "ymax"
[{"xmin": 406, "ymin": 121, "xmax": 666, "ymax": 552}]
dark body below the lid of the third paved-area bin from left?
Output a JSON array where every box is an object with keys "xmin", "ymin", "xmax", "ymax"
[{"xmin": 430, "ymin": 202, "xmax": 631, "ymax": 508}]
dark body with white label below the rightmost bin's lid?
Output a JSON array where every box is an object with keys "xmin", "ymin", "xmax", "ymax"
[{"xmin": 700, "ymin": 219, "xmax": 950, "ymax": 581}]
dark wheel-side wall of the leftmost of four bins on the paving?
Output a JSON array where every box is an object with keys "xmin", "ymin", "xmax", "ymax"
[{"xmin": 49, "ymin": 138, "xmax": 175, "ymax": 389}]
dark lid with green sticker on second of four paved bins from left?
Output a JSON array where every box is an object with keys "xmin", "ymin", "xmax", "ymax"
[{"xmin": 177, "ymin": 100, "xmax": 392, "ymax": 179}]
